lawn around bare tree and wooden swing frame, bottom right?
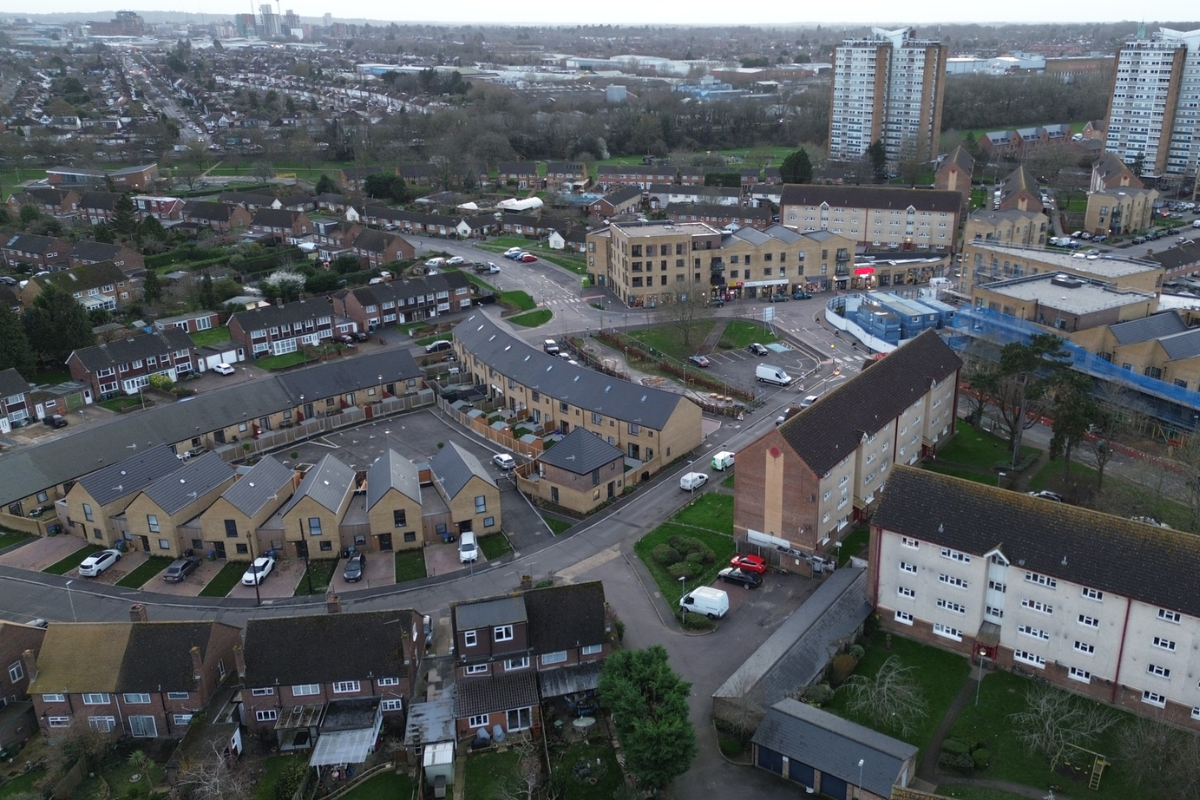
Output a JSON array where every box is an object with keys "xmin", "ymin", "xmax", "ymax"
[{"xmin": 950, "ymin": 672, "xmax": 1152, "ymax": 800}]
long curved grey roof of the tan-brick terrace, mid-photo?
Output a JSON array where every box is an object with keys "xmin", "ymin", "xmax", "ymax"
[{"xmin": 454, "ymin": 313, "xmax": 691, "ymax": 431}]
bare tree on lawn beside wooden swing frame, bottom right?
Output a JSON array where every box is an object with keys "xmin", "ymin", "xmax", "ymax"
[{"xmin": 1009, "ymin": 686, "xmax": 1117, "ymax": 770}]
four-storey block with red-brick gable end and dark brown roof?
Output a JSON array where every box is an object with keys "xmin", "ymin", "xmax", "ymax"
[{"xmin": 733, "ymin": 330, "xmax": 962, "ymax": 555}]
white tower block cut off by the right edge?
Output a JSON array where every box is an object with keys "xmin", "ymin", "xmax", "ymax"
[{"xmin": 1104, "ymin": 28, "xmax": 1200, "ymax": 178}]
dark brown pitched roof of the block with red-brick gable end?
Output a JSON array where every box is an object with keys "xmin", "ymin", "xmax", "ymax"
[{"xmin": 779, "ymin": 330, "xmax": 962, "ymax": 475}]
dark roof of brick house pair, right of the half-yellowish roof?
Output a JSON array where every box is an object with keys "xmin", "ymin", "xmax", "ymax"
[{"xmin": 238, "ymin": 609, "xmax": 414, "ymax": 687}]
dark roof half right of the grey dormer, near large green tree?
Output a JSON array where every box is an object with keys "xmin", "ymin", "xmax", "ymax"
[{"xmin": 522, "ymin": 582, "xmax": 605, "ymax": 654}]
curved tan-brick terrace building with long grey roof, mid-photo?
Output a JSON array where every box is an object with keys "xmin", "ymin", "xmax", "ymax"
[{"xmin": 454, "ymin": 313, "xmax": 703, "ymax": 486}]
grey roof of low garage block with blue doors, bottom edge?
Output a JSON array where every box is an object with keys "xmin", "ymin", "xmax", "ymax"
[{"xmin": 754, "ymin": 699, "xmax": 917, "ymax": 798}]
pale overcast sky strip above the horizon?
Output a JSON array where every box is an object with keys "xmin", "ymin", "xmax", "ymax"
[{"xmin": 0, "ymin": 0, "xmax": 1196, "ymax": 28}]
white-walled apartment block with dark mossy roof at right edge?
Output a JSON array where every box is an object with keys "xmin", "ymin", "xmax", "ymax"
[{"xmin": 868, "ymin": 461, "xmax": 1200, "ymax": 727}]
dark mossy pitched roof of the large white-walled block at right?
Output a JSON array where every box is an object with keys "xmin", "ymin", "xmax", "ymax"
[{"xmin": 873, "ymin": 465, "xmax": 1200, "ymax": 616}]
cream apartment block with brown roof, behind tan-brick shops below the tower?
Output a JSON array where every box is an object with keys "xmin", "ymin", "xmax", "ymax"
[{"xmin": 779, "ymin": 184, "xmax": 962, "ymax": 252}]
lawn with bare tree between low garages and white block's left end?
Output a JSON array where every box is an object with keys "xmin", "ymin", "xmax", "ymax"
[{"xmin": 827, "ymin": 631, "xmax": 971, "ymax": 748}]
